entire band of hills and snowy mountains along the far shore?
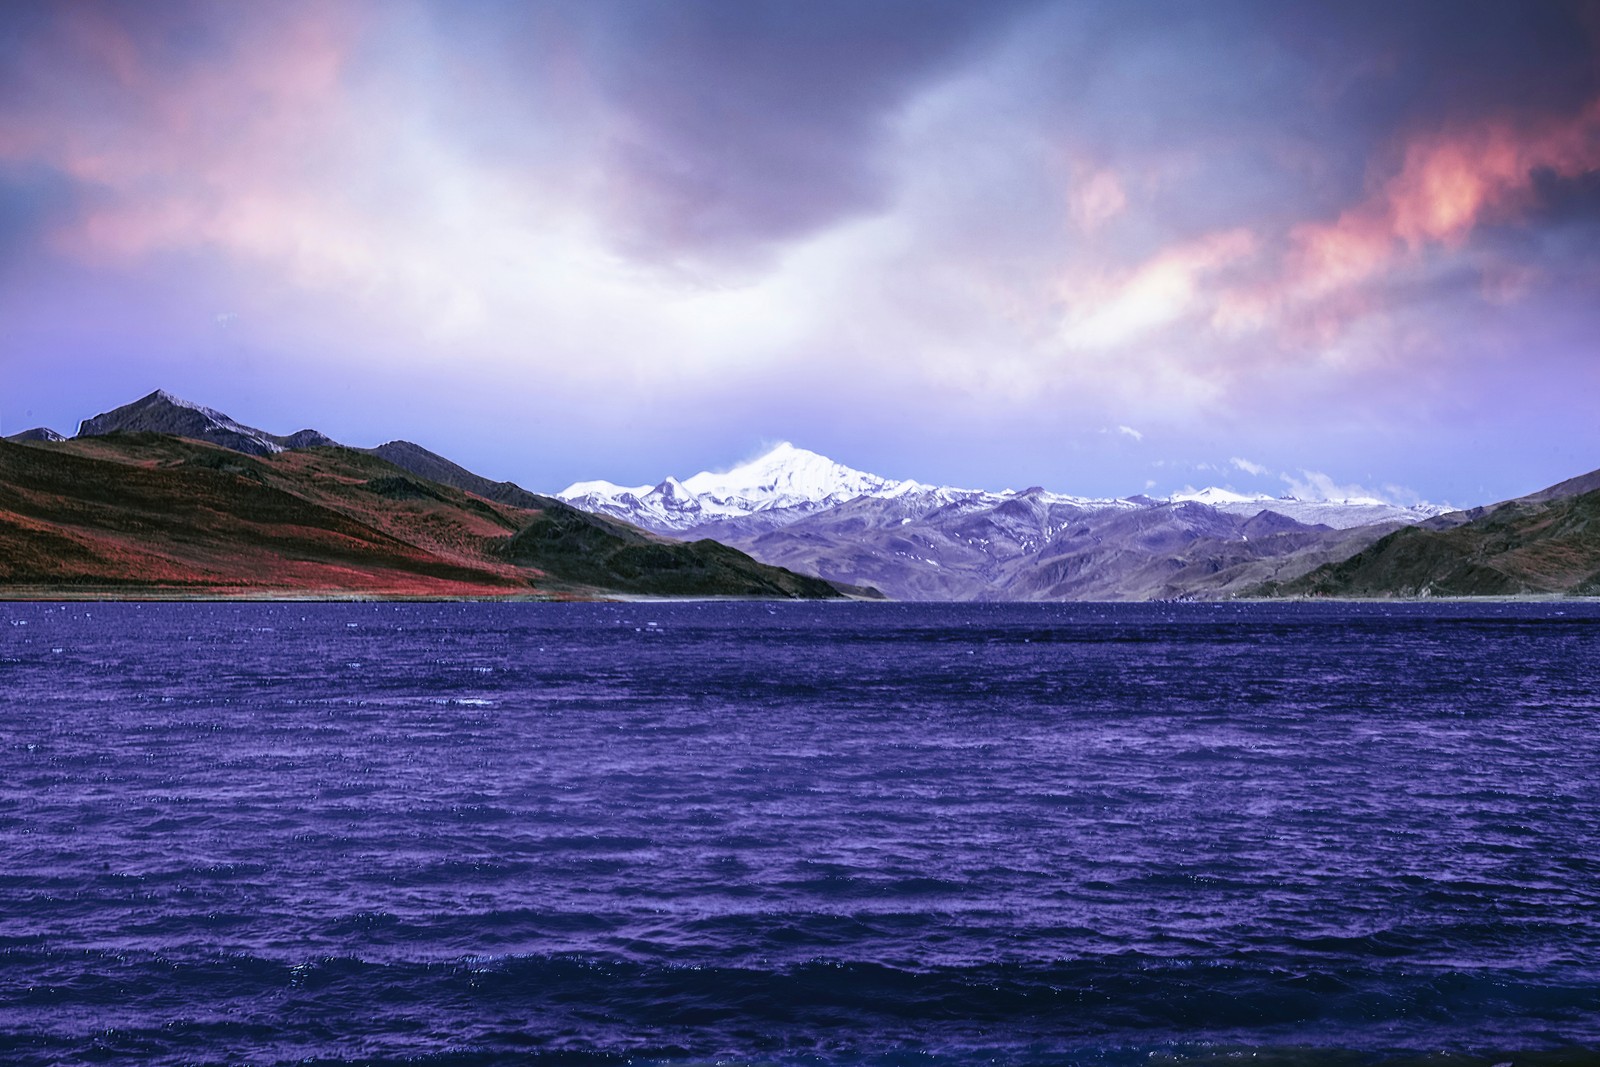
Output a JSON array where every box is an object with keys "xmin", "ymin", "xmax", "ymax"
[{"xmin": 0, "ymin": 392, "xmax": 1600, "ymax": 600}]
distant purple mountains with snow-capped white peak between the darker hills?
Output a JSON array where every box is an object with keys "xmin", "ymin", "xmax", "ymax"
[{"xmin": 557, "ymin": 445, "xmax": 1465, "ymax": 600}]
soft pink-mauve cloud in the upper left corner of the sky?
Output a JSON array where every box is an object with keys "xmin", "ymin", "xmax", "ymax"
[{"xmin": 0, "ymin": 3, "xmax": 360, "ymax": 262}]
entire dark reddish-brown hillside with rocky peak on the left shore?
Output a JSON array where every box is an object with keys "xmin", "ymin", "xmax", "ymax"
[{"xmin": 0, "ymin": 392, "xmax": 842, "ymax": 598}]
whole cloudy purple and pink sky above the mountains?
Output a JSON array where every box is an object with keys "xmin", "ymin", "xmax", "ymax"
[{"xmin": 0, "ymin": 0, "xmax": 1600, "ymax": 506}]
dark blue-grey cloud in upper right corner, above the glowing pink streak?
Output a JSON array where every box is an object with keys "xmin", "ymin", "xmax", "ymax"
[{"xmin": 979, "ymin": 0, "xmax": 1600, "ymax": 229}]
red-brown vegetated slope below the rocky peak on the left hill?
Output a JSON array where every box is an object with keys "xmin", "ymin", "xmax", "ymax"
[{"xmin": 0, "ymin": 437, "xmax": 531, "ymax": 597}]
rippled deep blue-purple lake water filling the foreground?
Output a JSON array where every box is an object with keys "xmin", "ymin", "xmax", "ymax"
[{"xmin": 0, "ymin": 603, "xmax": 1600, "ymax": 1065}]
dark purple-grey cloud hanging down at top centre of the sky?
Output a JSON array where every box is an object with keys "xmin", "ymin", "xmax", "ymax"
[{"xmin": 445, "ymin": 0, "xmax": 1029, "ymax": 261}]
